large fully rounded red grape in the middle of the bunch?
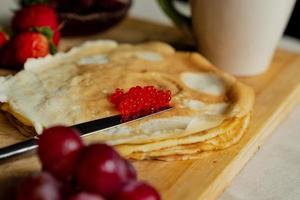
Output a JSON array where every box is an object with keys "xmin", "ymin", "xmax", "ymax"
[{"xmin": 75, "ymin": 144, "xmax": 127, "ymax": 197}]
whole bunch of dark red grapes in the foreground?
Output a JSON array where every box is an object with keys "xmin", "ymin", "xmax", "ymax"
[{"xmin": 17, "ymin": 126, "xmax": 160, "ymax": 200}]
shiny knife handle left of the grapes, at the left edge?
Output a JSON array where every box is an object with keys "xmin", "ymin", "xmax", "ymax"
[{"xmin": 0, "ymin": 138, "xmax": 37, "ymax": 160}]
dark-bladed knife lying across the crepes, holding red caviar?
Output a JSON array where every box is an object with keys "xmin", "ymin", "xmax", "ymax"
[{"xmin": 0, "ymin": 107, "xmax": 171, "ymax": 161}]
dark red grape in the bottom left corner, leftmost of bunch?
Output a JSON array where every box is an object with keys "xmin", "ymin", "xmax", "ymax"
[{"xmin": 17, "ymin": 172, "xmax": 62, "ymax": 200}]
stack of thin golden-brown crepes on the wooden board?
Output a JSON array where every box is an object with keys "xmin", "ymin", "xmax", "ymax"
[{"xmin": 0, "ymin": 40, "xmax": 254, "ymax": 160}]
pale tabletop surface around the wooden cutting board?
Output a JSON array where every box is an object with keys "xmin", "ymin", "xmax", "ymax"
[{"xmin": 0, "ymin": 0, "xmax": 300, "ymax": 200}]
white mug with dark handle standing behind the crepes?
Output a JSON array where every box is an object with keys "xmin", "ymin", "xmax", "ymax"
[{"xmin": 158, "ymin": 0, "xmax": 296, "ymax": 76}]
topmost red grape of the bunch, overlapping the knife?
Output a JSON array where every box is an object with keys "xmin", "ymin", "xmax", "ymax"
[{"xmin": 38, "ymin": 126, "xmax": 83, "ymax": 180}]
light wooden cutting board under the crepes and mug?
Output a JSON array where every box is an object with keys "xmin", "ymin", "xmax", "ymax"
[{"xmin": 0, "ymin": 19, "xmax": 300, "ymax": 200}]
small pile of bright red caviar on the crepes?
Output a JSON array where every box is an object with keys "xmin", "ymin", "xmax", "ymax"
[{"xmin": 109, "ymin": 86, "xmax": 171, "ymax": 121}]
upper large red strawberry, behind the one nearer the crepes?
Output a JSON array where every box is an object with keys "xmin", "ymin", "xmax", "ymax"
[{"xmin": 12, "ymin": 4, "xmax": 60, "ymax": 45}]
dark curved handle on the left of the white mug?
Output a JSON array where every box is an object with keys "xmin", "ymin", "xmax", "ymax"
[{"xmin": 157, "ymin": 0, "xmax": 192, "ymax": 33}]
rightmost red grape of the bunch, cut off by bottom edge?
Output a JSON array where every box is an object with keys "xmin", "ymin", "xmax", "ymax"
[{"xmin": 116, "ymin": 181, "xmax": 160, "ymax": 200}]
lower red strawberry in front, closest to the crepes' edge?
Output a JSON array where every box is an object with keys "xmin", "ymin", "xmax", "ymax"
[{"xmin": 13, "ymin": 32, "xmax": 50, "ymax": 64}]
